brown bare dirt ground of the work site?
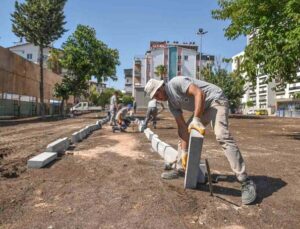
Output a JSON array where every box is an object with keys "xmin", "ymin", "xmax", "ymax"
[{"xmin": 0, "ymin": 110, "xmax": 300, "ymax": 228}]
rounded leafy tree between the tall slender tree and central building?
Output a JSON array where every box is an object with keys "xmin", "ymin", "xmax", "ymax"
[{"xmin": 61, "ymin": 25, "xmax": 120, "ymax": 97}]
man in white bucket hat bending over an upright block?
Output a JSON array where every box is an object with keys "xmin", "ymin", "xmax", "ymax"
[{"xmin": 145, "ymin": 76, "xmax": 256, "ymax": 204}]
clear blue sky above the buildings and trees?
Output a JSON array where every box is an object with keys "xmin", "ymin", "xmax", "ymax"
[{"xmin": 0, "ymin": 0, "xmax": 246, "ymax": 89}]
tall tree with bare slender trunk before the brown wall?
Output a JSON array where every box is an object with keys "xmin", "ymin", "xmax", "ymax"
[{"xmin": 11, "ymin": 0, "xmax": 67, "ymax": 117}]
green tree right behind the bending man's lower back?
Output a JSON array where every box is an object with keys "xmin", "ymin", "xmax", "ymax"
[{"xmin": 202, "ymin": 66, "xmax": 245, "ymax": 112}]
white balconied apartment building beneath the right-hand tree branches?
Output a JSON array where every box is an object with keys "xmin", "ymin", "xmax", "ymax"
[{"xmin": 232, "ymin": 52, "xmax": 300, "ymax": 117}]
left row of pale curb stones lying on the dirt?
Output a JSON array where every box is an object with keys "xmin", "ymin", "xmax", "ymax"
[{"xmin": 27, "ymin": 117, "xmax": 109, "ymax": 168}]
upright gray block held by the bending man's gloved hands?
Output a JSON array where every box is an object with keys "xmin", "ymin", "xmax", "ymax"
[{"xmin": 184, "ymin": 129, "xmax": 204, "ymax": 189}]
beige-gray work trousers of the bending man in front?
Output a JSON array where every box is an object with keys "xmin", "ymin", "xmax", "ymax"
[{"xmin": 177, "ymin": 100, "xmax": 247, "ymax": 182}]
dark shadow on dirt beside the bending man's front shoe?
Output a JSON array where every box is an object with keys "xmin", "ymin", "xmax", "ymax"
[{"xmin": 197, "ymin": 174, "xmax": 287, "ymax": 204}]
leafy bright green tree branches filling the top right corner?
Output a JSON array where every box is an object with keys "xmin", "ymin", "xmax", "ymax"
[{"xmin": 212, "ymin": 0, "xmax": 300, "ymax": 85}]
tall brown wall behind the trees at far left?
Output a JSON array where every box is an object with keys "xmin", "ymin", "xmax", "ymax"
[{"xmin": 0, "ymin": 46, "xmax": 67, "ymax": 115}]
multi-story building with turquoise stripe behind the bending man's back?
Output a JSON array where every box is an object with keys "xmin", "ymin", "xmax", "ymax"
[{"xmin": 132, "ymin": 41, "xmax": 214, "ymax": 106}]
